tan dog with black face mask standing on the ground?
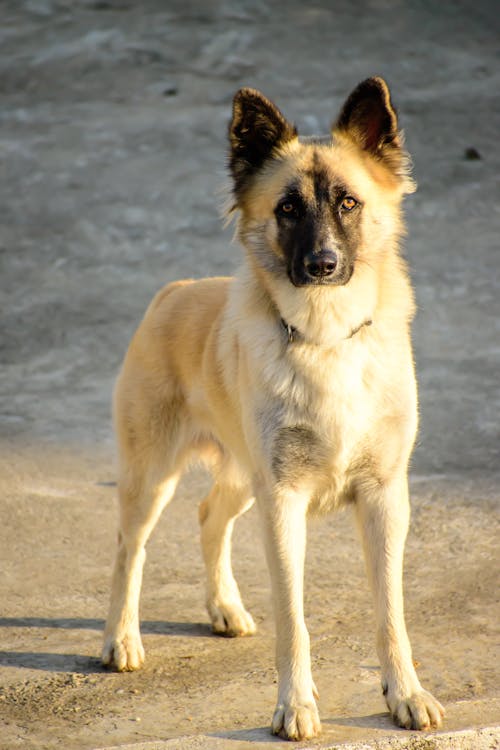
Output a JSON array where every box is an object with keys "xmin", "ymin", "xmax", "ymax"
[{"xmin": 102, "ymin": 78, "xmax": 444, "ymax": 740}]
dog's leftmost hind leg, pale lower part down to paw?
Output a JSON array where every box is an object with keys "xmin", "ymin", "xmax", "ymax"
[{"xmin": 102, "ymin": 470, "xmax": 178, "ymax": 672}]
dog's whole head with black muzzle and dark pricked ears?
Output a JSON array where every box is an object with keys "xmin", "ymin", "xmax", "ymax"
[{"xmin": 229, "ymin": 78, "xmax": 415, "ymax": 287}]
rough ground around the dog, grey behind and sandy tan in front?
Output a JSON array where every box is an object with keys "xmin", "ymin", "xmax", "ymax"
[{"xmin": 0, "ymin": 0, "xmax": 500, "ymax": 750}]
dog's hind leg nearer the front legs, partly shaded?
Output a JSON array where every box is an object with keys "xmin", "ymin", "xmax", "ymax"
[{"xmin": 199, "ymin": 482, "xmax": 255, "ymax": 636}]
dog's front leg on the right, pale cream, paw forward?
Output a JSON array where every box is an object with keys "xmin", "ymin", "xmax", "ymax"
[{"xmin": 356, "ymin": 476, "xmax": 444, "ymax": 729}]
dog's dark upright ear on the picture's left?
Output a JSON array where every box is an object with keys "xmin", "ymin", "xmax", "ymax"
[{"xmin": 229, "ymin": 88, "xmax": 297, "ymax": 197}]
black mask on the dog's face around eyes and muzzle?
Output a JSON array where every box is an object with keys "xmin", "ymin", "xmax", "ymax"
[{"xmin": 274, "ymin": 168, "xmax": 362, "ymax": 286}]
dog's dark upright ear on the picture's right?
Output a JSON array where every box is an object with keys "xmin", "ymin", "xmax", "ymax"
[{"xmin": 332, "ymin": 78, "xmax": 415, "ymax": 192}]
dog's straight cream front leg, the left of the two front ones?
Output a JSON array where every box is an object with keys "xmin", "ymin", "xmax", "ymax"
[{"xmin": 258, "ymin": 489, "xmax": 321, "ymax": 740}]
